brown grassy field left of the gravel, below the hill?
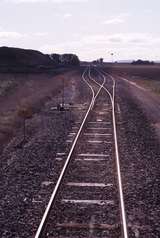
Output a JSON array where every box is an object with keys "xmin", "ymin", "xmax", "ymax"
[{"xmin": 0, "ymin": 72, "xmax": 77, "ymax": 149}]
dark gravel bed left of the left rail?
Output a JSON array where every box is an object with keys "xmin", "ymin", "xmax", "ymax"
[{"xmin": 0, "ymin": 68, "xmax": 89, "ymax": 238}]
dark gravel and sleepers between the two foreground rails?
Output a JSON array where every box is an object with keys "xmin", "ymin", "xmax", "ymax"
[{"xmin": 42, "ymin": 81, "xmax": 121, "ymax": 238}]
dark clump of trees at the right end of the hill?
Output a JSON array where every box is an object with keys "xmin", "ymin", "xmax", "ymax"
[{"xmin": 50, "ymin": 54, "xmax": 80, "ymax": 66}]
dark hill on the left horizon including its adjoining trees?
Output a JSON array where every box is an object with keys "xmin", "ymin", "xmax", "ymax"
[{"xmin": 0, "ymin": 47, "xmax": 80, "ymax": 73}]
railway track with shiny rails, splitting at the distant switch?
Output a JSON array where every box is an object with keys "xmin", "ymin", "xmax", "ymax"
[{"xmin": 35, "ymin": 67, "xmax": 128, "ymax": 238}]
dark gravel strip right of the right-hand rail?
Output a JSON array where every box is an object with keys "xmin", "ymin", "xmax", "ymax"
[{"xmin": 117, "ymin": 80, "xmax": 160, "ymax": 238}]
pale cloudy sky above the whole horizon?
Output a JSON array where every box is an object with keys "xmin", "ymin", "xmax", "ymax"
[{"xmin": 0, "ymin": 0, "xmax": 160, "ymax": 61}]
